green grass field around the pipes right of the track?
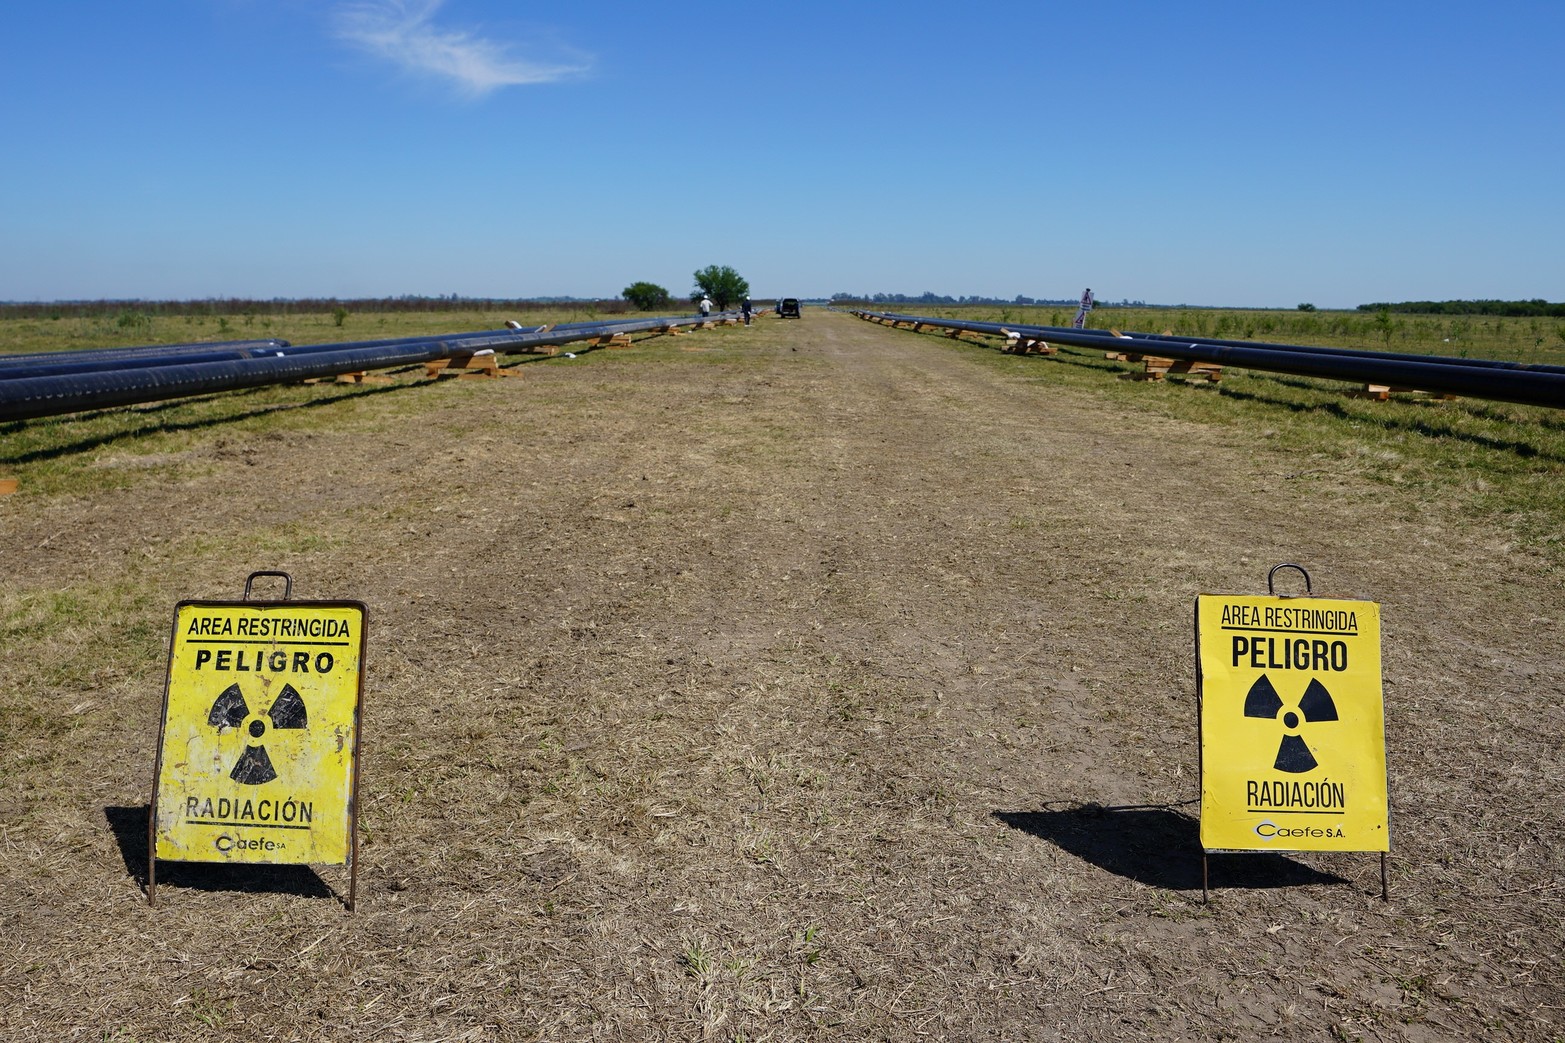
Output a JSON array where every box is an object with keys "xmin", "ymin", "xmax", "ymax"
[{"xmin": 857, "ymin": 305, "xmax": 1565, "ymax": 564}]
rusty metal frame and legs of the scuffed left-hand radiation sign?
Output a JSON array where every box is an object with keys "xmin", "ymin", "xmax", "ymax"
[{"xmin": 147, "ymin": 572, "xmax": 369, "ymax": 911}]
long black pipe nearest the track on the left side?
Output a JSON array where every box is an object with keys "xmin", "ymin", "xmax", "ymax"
[{"xmin": 0, "ymin": 313, "xmax": 732, "ymax": 421}]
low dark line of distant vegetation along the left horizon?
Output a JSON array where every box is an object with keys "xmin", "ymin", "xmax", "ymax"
[{"xmin": 0, "ymin": 293, "xmax": 631, "ymax": 319}]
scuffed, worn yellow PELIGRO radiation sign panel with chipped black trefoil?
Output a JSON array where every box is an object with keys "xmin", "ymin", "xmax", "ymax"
[{"xmin": 152, "ymin": 601, "xmax": 365, "ymax": 864}]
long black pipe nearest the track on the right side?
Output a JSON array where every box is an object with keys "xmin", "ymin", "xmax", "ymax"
[{"xmin": 858, "ymin": 312, "xmax": 1565, "ymax": 409}]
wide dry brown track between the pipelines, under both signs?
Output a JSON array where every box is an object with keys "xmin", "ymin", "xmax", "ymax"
[{"xmin": 0, "ymin": 312, "xmax": 1565, "ymax": 1041}]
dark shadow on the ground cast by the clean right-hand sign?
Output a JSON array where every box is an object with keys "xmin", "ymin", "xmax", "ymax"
[{"xmin": 994, "ymin": 803, "xmax": 1347, "ymax": 891}]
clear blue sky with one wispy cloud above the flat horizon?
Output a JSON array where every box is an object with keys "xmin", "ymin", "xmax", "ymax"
[{"xmin": 0, "ymin": 0, "xmax": 1565, "ymax": 307}]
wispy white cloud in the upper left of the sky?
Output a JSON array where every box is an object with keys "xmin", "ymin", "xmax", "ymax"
[{"xmin": 336, "ymin": 0, "xmax": 585, "ymax": 97}]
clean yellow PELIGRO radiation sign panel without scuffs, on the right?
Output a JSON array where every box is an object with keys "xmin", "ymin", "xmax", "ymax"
[{"xmin": 1196, "ymin": 594, "xmax": 1391, "ymax": 852}]
